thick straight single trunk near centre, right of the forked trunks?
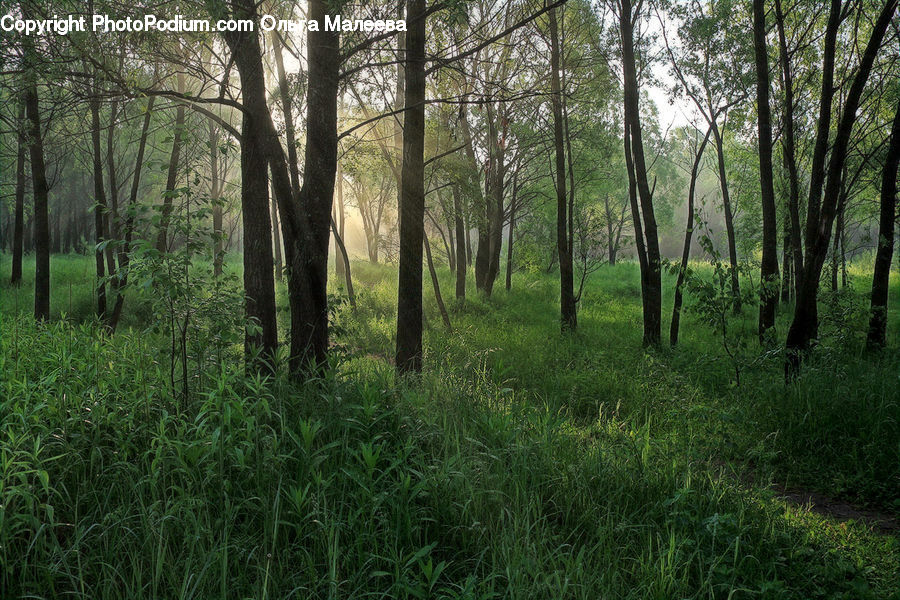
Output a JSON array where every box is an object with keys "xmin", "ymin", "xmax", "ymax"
[{"xmin": 396, "ymin": 0, "xmax": 426, "ymax": 373}]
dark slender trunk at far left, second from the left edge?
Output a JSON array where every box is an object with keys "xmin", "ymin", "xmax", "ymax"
[{"xmin": 25, "ymin": 81, "xmax": 50, "ymax": 321}]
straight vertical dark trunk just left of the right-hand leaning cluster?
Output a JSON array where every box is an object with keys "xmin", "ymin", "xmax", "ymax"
[{"xmin": 753, "ymin": 0, "xmax": 778, "ymax": 343}]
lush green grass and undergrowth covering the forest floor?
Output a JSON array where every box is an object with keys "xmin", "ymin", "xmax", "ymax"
[{"xmin": 0, "ymin": 256, "xmax": 900, "ymax": 599}]
